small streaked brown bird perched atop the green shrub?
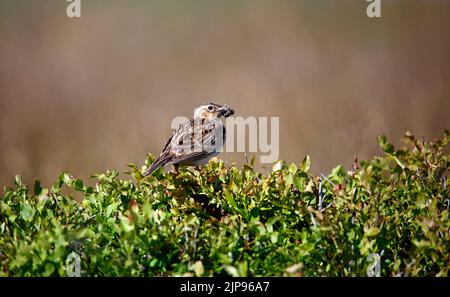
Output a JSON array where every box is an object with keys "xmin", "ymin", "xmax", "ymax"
[{"xmin": 144, "ymin": 102, "xmax": 234, "ymax": 176}]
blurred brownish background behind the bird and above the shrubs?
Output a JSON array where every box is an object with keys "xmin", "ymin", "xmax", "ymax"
[{"xmin": 0, "ymin": 0, "xmax": 450, "ymax": 186}]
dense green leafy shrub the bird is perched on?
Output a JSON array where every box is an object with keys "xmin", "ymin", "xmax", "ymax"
[{"xmin": 0, "ymin": 131, "xmax": 450, "ymax": 276}]
